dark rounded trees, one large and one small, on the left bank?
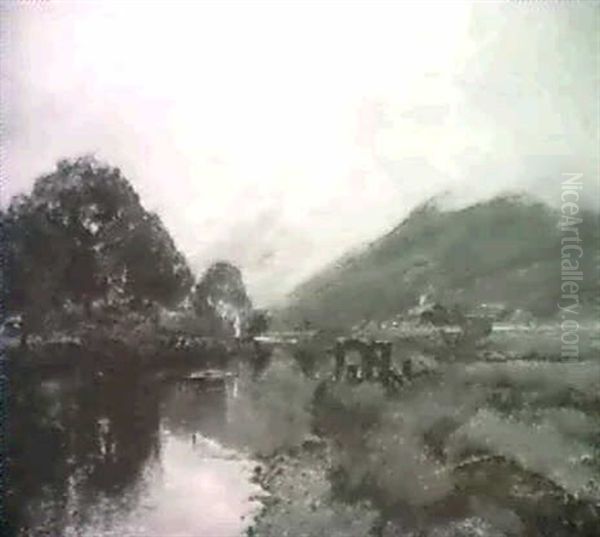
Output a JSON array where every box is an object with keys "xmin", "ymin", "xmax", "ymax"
[{"xmin": 0, "ymin": 157, "xmax": 268, "ymax": 344}]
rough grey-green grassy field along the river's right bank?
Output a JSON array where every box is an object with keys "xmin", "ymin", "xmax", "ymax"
[{"xmin": 240, "ymin": 327, "xmax": 600, "ymax": 537}]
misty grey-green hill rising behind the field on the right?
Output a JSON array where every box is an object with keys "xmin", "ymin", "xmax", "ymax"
[{"xmin": 282, "ymin": 195, "xmax": 600, "ymax": 326}]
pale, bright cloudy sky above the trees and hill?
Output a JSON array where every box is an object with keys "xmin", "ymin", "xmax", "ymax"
[{"xmin": 0, "ymin": 0, "xmax": 600, "ymax": 305}]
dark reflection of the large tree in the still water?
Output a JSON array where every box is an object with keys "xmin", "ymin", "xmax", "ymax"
[{"xmin": 7, "ymin": 356, "xmax": 159, "ymax": 535}]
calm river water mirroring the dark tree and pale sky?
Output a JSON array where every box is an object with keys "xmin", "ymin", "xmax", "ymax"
[{"xmin": 11, "ymin": 366, "xmax": 260, "ymax": 537}]
